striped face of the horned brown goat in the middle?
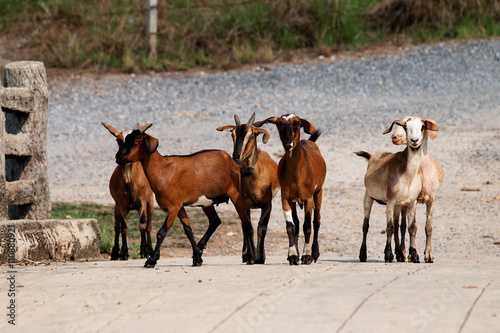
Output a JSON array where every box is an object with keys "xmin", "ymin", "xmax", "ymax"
[{"xmin": 217, "ymin": 113, "xmax": 271, "ymax": 164}]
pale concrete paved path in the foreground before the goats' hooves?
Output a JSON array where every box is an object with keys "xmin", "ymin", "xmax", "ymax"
[{"xmin": 0, "ymin": 253, "xmax": 500, "ymax": 332}]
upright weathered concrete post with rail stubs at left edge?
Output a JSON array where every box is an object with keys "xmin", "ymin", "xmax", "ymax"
[{"xmin": 0, "ymin": 61, "xmax": 51, "ymax": 220}]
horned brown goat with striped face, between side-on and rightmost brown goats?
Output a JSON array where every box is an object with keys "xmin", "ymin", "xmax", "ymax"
[{"xmin": 217, "ymin": 112, "xmax": 279, "ymax": 264}]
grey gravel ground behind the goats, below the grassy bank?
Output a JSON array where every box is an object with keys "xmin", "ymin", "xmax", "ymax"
[{"xmin": 48, "ymin": 40, "xmax": 500, "ymax": 258}]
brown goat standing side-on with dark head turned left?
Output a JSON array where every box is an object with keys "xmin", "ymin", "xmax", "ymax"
[{"xmin": 116, "ymin": 124, "xmax": 255, "ymax": 268}]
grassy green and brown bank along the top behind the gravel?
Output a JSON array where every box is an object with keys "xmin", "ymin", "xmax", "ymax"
[{"xmin": 0, "ymin": 0, "xmax": 500, "ymax": 72}]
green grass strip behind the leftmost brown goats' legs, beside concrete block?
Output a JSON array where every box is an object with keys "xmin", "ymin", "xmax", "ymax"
[{"xmin": 52, "ymin": 203, "xmax": 219, "ymax": 259}]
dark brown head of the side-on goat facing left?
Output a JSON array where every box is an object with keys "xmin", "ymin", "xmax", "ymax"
[{"xmin": 115, "ymin": 124, "xmax": 158, "ymax": 165}]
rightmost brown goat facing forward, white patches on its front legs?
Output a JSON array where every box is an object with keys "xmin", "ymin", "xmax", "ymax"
[{"xmin": 254, "ymin": 114, "xmax": 326, "ymax": 265}]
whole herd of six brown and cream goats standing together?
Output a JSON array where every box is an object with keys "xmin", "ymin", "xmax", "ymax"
[{"xmin": 102, "ymin": 113, "xmax": 444, "ymax": 267}]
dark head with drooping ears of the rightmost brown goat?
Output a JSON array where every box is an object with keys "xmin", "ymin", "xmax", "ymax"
[{"xmin": 254, "ymin": 114, "xmax": 315, "ymax": 152}]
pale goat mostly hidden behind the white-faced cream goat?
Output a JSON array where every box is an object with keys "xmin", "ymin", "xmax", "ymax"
[{"xmin": 391, "ymin": 117, "xmax": 444, "ymax": 263}]
